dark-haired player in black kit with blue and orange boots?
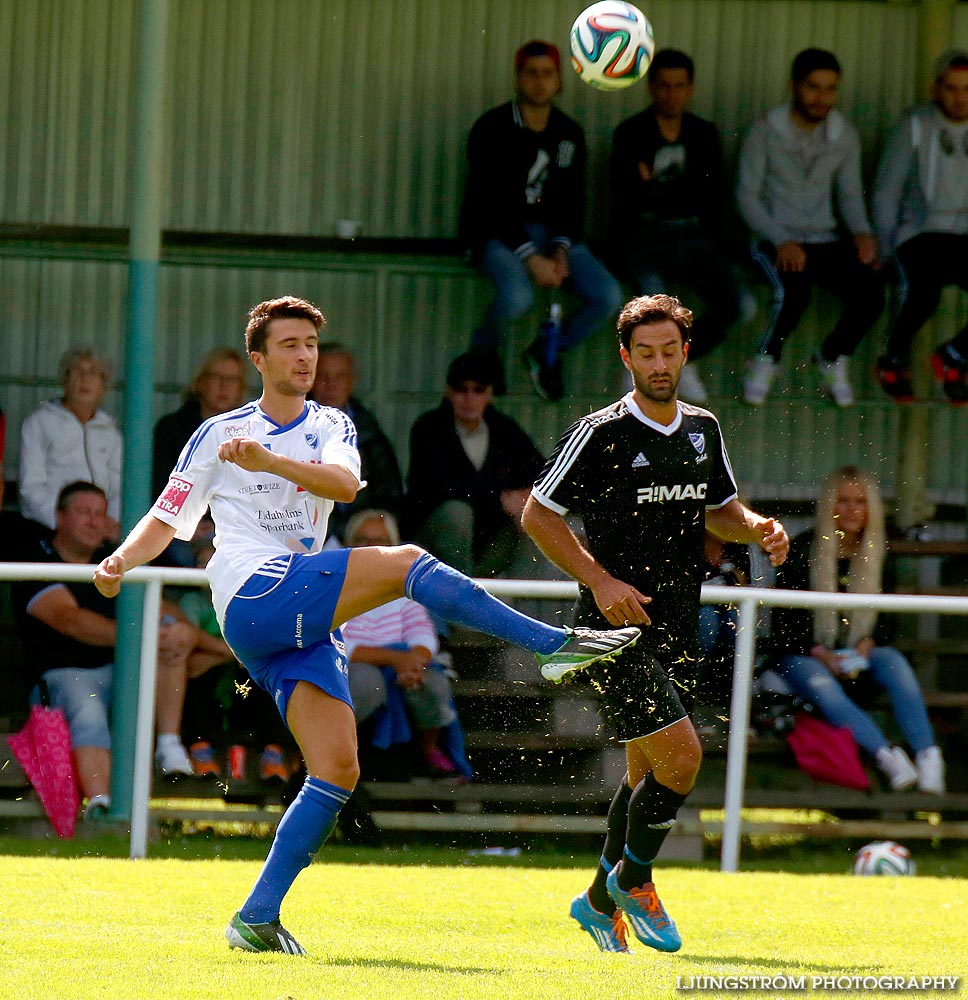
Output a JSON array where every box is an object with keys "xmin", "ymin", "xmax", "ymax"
[{"xmin": 522, "ymin": 295, "xmax": 790, "ymax": 951}]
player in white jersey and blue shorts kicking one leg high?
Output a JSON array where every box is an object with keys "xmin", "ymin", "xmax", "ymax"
[{"xmin": 94, "ymin": 296, "xmax": 640, "ymax": 955}]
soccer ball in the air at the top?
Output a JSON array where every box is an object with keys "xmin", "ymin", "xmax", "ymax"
[{"xmin": 571, "ymin": 0, "xmax": 655, "ymax": 90}]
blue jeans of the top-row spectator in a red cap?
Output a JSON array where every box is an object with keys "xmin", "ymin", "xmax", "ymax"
[{"xmin": 474, "ymin": 225, "xmax": 623, "ymax": 351}]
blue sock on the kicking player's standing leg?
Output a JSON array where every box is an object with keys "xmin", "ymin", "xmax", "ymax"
[{"xmin": 239, "ymin": 777, "xmax": 352, "ymax": 924}]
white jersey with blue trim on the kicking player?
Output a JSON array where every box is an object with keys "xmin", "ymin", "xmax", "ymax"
[{"xmin": 151, "ymin": 401, "xmax": 365, "ymax": 624}]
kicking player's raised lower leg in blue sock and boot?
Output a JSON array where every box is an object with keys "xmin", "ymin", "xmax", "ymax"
[{"xmin": 404, "ymin": 552, "xmax": 641, "ymax": 682}]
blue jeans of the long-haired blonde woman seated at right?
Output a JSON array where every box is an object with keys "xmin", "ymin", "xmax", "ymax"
[{"xmin": 780, "ymin": 646, "xmax": 934, "ymax": 757}]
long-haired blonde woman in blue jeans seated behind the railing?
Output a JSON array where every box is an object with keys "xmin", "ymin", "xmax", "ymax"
[{"xmin": 773, "ymin": 466, "xmax": 945, "ymax": 795}]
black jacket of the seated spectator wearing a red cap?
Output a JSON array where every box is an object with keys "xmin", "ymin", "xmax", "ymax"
[{"xmin": 460, "ymin": 101, "xmax": 585, "ymax": 253}]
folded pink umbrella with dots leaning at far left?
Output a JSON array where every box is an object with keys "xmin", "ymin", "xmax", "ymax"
[{"xmin": 7, "ymin": 705, "xmax": 80, "ymax": 837}]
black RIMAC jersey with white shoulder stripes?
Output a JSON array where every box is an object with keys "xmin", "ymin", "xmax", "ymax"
[{"xmin": 533, "ymin": 393, "xmax": 737, "ymax": 658}]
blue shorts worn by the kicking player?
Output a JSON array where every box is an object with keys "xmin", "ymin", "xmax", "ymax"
[{"xmin": 223, "ymin": 549, "xmax": 353, "ymax": 721}]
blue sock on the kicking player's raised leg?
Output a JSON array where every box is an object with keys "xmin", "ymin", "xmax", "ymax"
[{"xmin": 404, "ymin": 552, "xmax": 566, "ymax": 655}]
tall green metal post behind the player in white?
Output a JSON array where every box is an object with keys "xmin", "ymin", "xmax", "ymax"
[{"xmin": 111, "ymin": 0, "xmax": 168, "ymax": 817}]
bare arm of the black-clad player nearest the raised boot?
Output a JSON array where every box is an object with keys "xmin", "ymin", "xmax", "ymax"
[{"xmin": 521, "ymin": 494, "xmax": 651, "ymax": 628}]
